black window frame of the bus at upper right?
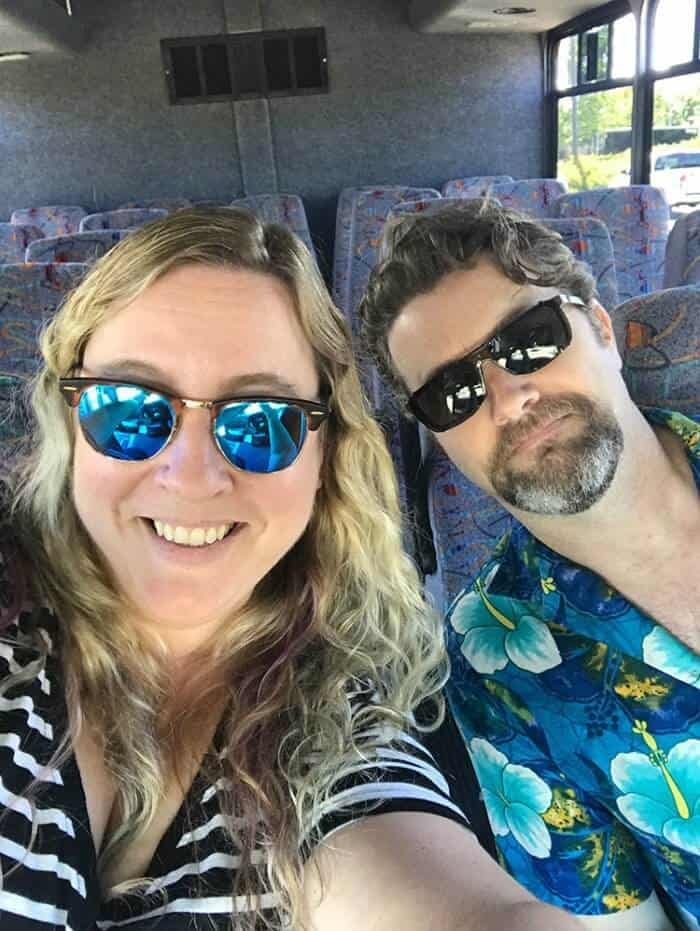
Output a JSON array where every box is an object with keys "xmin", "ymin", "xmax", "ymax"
[{"xmin": 544, "ymin": 0, "xmax": 700, "ymax": 184}]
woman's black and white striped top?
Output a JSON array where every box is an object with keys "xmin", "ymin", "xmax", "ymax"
[{"xmin": 0, "ymin": 548, "xmax": 474, "ymax": 931}]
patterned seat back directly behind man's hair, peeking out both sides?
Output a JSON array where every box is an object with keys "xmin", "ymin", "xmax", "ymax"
[{"xmin": 391, "ymin": 197, "xmax": 618, "ymax": 309}]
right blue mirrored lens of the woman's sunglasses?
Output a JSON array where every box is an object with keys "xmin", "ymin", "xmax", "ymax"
[{"xmin": 216, "ymin": 400, "xmax": 307, "ymax": 473}]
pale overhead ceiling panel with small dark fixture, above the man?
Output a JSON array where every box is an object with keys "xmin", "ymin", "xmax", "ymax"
[{"xmin": 408, "ymin": 0, "xmax": 616, "ymax": 33}]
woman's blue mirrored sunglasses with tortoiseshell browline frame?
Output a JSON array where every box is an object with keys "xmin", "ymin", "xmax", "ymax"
[{"xmin": 59, "ymin": 378, "xmax": 330, "ymax": 474}]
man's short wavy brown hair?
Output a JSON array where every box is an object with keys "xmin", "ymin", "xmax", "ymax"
[{"xmin": 359, "ymin": 197, "xmax": 596, "ymax": 405}]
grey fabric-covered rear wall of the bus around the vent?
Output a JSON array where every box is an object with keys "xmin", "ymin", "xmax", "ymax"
[{"xmin": 0, "ymin": 0, "xmax": 543, "ymax": 269}]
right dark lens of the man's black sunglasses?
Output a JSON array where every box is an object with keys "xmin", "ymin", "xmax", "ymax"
[{"xmin": 497, "ymin": 303, "xmax": 571, "ymax": 375}]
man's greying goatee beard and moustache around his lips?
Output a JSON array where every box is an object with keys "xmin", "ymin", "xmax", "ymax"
[{"xmin": 489, "ymin": 393, "xmax": 624, "ymax": 515}]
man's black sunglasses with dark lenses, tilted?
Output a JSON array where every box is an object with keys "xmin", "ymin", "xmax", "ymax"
[{"xmin": 408, "ymin": 294, "xmax": 585, "ymax": 433}]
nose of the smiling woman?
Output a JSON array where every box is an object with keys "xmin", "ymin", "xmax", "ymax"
[{"xmin": 156, "ymin": 408, "xmax": 234, "ymax": 500}]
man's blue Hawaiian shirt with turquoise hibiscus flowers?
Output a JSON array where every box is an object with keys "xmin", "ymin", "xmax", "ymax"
[{"xmin": 447, "ymin": 410, "xmax": 700, "ymax": 929}]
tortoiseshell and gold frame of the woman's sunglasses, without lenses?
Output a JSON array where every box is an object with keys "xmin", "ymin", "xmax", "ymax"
[{"xmin": 58, "ymin": 378, "xmax": 331, "ymax": 475}]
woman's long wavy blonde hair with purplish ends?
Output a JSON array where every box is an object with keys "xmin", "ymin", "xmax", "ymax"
[{"xmin": 2, "ymin": 208, "xmax": 446, "ymax": 928}]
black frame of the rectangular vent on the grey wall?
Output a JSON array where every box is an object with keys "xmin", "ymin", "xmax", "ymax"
[{"xmin": 160, "ymin": 26, "xmax": 328, "ymax": 106}]
